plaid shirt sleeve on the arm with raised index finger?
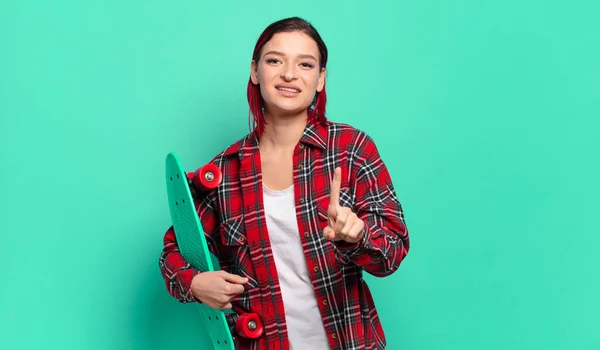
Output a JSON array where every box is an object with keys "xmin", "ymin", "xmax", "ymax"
[{"xmin": 336, "ymin": 135, "xmax": 410, "ymax": 277}]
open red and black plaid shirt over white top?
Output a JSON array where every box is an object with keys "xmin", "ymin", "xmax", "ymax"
[{"xmin": 159, "ymin": 122, "xmax": 409, "ymax": 350}]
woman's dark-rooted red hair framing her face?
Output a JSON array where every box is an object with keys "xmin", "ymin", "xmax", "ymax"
[{"xmin": 247, "ymin": 17, "xmax": 327, "ymax": 135}]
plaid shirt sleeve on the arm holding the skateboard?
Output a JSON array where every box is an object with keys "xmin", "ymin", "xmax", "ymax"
[{"xmin": 159, "ymin": 197, "xmax": 219, "ymax": 303}]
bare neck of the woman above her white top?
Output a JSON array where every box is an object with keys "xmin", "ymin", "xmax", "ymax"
[{"xmin": 260, "ymin": 108, "xmax": 308, "ymax": 148}]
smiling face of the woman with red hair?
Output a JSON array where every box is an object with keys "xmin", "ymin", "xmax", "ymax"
[{"xmin": 250, "ymin": 32, "xmax": 325, "ymax": 115}]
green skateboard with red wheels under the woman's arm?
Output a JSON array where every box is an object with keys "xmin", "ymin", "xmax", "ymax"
[{"xmin": 165, "ymin": 152, "xmax": 263, "ymax": 350}]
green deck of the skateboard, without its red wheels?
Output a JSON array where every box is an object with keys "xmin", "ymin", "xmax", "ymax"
[{"xmin": 166, "ymin": 153, "xmax": 235, "ymax": 350}]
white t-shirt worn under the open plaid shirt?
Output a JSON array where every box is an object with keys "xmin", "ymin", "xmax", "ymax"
[{"xmin": 263, "ymin": 185, "xmax": 330, "ymax": 350}]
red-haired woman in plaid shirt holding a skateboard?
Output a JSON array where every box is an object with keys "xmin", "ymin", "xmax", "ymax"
[{"xmin": 160, "ymin": 17, "xmax": 409, "ymax": 349}]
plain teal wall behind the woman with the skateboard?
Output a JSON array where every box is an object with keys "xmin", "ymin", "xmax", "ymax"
[{"xmin": 0, "ymin": 0, "xmax": 600, "ymax": 350}]
